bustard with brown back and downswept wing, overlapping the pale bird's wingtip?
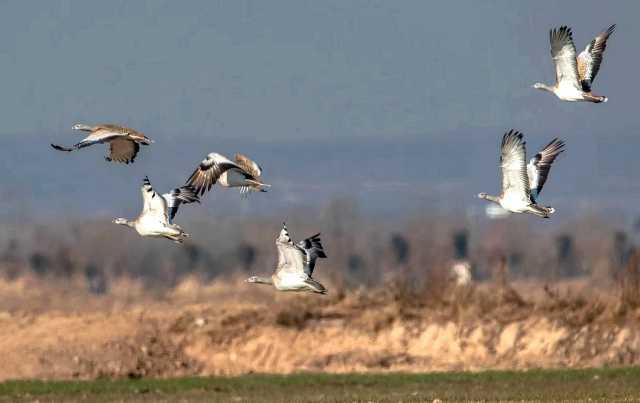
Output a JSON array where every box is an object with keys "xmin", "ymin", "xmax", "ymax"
[{"xmin": 187, "ymin": 153, "xmax": 271, "ymax": 197}]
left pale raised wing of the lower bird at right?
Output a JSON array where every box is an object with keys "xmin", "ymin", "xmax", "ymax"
[{"xmin": 500, "ymin": 130, "xmax": 531, "ymax": 204}]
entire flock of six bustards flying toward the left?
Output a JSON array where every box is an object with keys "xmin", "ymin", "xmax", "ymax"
[{"xmin": 51, "ymin": 25, "xmax": 615, "ymax": 294}]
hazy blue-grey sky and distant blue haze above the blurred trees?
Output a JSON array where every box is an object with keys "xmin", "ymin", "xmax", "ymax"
[{"xmin": 0, "ymin": 0, "xmax": 640, "ymax": 219}]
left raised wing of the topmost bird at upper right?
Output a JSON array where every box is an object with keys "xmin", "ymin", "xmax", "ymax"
[{"xmin": 549, "ymin": 26, "xmax": 580, "ymax": 89}]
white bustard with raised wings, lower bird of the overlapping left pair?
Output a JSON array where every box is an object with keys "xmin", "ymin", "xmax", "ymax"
[{"xmin": 113, "ymin": 177, "xmax": 200, "ymax": 243}]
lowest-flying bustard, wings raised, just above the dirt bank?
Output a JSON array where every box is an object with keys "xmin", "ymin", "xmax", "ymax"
[{"xmin": 246, "ymin": 224, "xmax": 327, "ymax": 294}]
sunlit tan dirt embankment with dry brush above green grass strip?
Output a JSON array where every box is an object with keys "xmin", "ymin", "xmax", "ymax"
[{"xmin": 0, "ymin": 280, "xmax": 640, "ymax": 380}]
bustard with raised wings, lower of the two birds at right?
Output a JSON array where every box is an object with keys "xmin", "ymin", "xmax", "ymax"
[{"xmin": 478, "ymin": 130, "xmax": 564, "ymax": 218}]
